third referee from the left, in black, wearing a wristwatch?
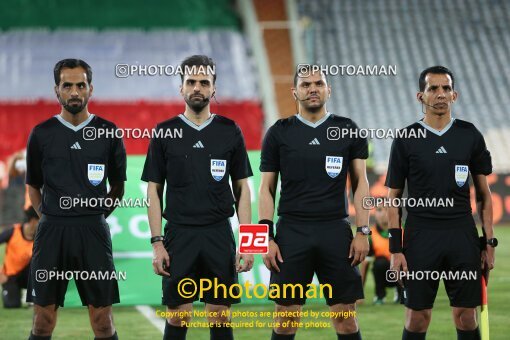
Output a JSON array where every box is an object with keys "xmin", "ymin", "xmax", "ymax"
[{"xmin": 259, "ymin": 66, "xmax": 370, "ymax": 340}]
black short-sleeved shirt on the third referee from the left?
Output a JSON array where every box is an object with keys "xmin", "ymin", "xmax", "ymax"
[{"xmin": 260, "ymin": 113, "xmax": 368, "ymax": 221}]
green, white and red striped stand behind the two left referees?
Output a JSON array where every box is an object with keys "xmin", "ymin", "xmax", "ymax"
[{"xmin": 0, "ymin": 0, "xmax": 263, "ymax": 162}]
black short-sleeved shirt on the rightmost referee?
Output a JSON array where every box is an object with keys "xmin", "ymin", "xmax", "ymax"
[{"xmin": 386, "ymin": 119, "xmax": 492, "ymax": 228}]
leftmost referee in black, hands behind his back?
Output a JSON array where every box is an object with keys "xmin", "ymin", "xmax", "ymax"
[{"xmin": 26, "ymin": 59, "xmax": 126, "ymax": 339}]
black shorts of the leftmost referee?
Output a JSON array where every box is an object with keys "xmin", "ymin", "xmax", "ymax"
[{"xmin": 27, "ymin": 215, "xmax": 119, "ymax": 307}]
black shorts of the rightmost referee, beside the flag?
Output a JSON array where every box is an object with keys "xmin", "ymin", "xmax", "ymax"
[{"xmin": 403, "ymin": 225, "xmax": 481, "ymax": 310}]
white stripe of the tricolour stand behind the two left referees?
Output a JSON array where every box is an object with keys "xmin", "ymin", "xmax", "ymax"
[{"xmin": 0, "ymin": 29, "xmax": 258, "ymax": 101}]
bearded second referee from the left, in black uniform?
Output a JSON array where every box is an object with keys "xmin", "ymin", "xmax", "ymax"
[{"xmin": 142, "ymin": 55, "xmax": 253, "ymax": 339}]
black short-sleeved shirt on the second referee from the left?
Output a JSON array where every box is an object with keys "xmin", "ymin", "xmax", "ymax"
[{"xmin": 142, "ymin": 114, "xmax": 253, "ymax": 226}]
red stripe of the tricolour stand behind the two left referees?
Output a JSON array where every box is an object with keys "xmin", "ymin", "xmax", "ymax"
[{"xmin": 0, "ymin": 100, "xmax": 264, "ymax": 160}]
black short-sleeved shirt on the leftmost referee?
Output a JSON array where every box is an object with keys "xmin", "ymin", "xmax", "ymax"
[{"xmin": 26, "ymin": 114, "xmax": 126, "ymax": 216}]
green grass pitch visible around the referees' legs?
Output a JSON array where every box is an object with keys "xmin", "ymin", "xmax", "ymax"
[{"xmin": 0, "ymin": 226, "xmax": 510, "ymax": 340}]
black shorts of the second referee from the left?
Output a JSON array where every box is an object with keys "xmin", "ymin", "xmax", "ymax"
[{"xmin": 162, "ymin": 220, "xmax": 241, "ymax": 308}]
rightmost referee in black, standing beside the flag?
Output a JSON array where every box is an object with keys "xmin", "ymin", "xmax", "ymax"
[{"xmin": 386, "ymin": 66, "xmax": 497, "ymax": 340}]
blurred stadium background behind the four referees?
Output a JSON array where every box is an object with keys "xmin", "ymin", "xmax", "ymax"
[{"xmin": 0, "ymin": 0, "xmax": 510, "ymax": 339}]
